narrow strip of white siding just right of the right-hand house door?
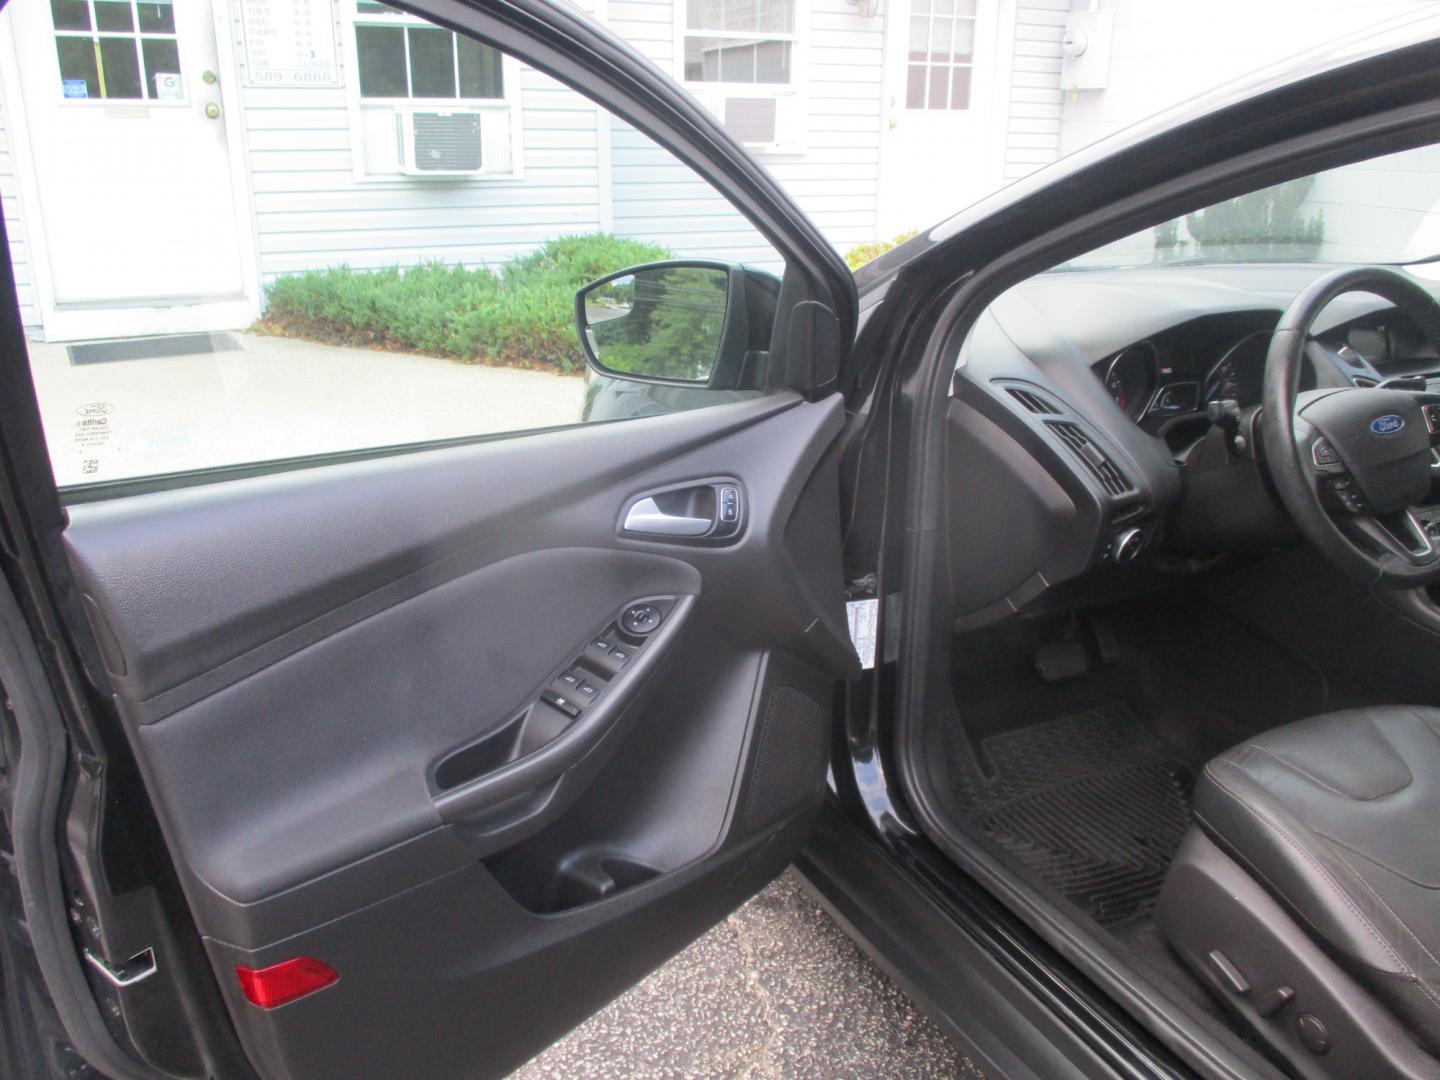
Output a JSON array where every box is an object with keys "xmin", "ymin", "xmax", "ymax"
[{"xmin": 1002, "ymin": 0, "xmax": 1070, "ymax": 183}]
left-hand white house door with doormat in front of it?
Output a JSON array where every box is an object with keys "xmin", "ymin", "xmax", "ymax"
[{"xmin": 6, "ymin": 0, "xmax": 255, "ymax": 338}]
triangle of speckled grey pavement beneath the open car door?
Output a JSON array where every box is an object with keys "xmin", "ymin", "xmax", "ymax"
[{"xmin": 513, "ymin": 871, "xmax": 981, "ymax": 1080}]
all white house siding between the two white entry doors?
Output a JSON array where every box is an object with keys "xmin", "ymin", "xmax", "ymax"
[{"xmin": 235, "ymin": 0, "xmax": 883, "ymax": 292}]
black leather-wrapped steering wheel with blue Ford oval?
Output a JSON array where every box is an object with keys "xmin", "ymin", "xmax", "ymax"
[{"xmin": 1260, "ymin": 266, "xmax": 1440, "ymax": 589}]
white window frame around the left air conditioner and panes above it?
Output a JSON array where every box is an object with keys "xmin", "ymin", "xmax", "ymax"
[{"xmin": 338, "ymin": 0, "xmax": 526, "ymax": 186}]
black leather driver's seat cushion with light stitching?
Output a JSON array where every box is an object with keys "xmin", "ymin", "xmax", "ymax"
[{"xmin": 1195, "ymin": 706, "xmax": 1440, "ymax": 1053}]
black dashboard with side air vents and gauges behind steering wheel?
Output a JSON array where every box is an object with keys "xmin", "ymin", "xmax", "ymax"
[{"xmin": 948, "ymin": 265, "xmax": 1440, "ymax": 628}]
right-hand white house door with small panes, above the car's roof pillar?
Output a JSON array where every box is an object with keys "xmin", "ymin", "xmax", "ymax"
[{"xmin": 880, "ymin": 0, "xmax": 998, "ymax": 238}]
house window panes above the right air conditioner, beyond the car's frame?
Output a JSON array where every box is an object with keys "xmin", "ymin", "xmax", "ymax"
[{"xmin": 684, "ymin": 0, "xmax": 796, "ymax": 85}]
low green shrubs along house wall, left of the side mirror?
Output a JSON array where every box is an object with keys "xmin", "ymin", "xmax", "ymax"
[{"xmin": 261, "ymin": 233, "xmax": 670, "ymax": 372}]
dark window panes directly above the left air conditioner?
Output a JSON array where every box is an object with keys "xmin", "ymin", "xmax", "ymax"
[{"xmin": 356, "ymin": 0, "xmax": 505, "ymax": 101}]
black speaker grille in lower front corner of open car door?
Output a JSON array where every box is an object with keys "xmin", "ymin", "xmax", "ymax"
[{"xmin": 744, "ymin": 687, "xmax": 827, "ymax": 832}]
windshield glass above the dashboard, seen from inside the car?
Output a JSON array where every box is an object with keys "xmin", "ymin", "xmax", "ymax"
[{"xmin": 1057, "ymin": 145, "xmax": 1440, "ymax": 269}]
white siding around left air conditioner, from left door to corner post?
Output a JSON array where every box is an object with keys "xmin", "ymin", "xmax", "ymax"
[{"xmin": 236, "ymin": 23, "xmax": 602, "ymax": 298}]
